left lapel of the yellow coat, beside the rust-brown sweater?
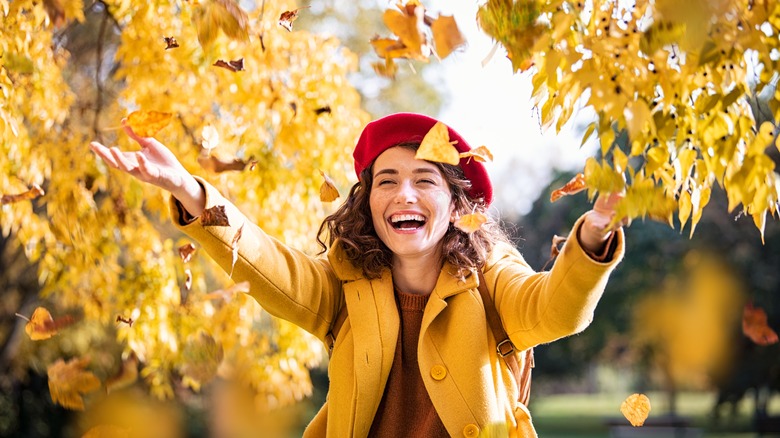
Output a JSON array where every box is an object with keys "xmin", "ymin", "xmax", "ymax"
[{"xmin": 344, "ymin": 270, "xmax": 399, "ymax": 436}]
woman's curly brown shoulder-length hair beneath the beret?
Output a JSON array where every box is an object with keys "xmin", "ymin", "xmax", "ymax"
[{"xmin": 317, "ymin": 142, "xmax": 509, "ymax": 279}]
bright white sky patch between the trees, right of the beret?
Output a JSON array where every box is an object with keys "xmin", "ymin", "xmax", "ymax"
[{"xmin": 426, "ymin": 0, "xmax": 593, "ymax": 215}]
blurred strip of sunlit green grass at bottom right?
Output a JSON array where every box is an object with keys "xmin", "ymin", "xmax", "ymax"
[{"xmin": 531, "ymin": 393, "xmax": 780, "ymax": 438}]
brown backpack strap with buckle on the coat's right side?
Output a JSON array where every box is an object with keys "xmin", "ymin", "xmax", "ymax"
[{"xmin": 477, "ymin": 269, "xmax": 534, "ymax": 406}]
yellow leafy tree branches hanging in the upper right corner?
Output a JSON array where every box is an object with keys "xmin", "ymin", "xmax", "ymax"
[{"xmin": 477, "ymin": 0, "xmax": 780, "ymax": 240}]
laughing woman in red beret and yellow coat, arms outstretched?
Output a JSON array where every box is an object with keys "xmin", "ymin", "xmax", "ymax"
[{"xmin": 91, "ymin": 113, "xmax": 623, "ymax": 437}]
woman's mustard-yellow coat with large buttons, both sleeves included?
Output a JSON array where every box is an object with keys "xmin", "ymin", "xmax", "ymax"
[{"xmin": 172, "ymin": 180, "xmax": 624, "ymax": 438}]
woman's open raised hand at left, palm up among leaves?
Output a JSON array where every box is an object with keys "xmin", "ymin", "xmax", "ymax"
[{"xmin": 90, "ymin": 120, "xmax": 206, "ymax": 217}]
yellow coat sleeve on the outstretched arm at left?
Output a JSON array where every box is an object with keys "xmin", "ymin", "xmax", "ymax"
[{"xmin": 171, "ymin": 178, "xmax": 341, "ymax": 339}]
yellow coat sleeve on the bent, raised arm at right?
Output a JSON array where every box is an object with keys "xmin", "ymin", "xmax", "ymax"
[{"xmin": 485, "ymin": 217, "xmax": 624, "ymax": 350}]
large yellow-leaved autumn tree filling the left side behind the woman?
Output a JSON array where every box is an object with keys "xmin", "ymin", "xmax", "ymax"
[{"xmin": 0, "ymin": 0, "xmax": 368, "ymax": 432}]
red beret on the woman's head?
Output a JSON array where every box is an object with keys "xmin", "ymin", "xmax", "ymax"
[{"xmin": 352, "ymin": 113, "xmax": 493, "ymax": 205}]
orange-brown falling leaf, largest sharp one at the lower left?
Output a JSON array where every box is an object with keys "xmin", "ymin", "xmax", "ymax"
[{"xmin": 47, "ymin": 358, "xmax": 100, "ymax": 411}]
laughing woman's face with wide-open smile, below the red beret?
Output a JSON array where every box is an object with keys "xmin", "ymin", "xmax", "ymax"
[{"xmin": 369, "ymin": 147, "xmax": 455, "ymax": 257}]
